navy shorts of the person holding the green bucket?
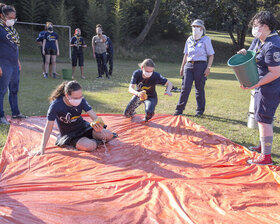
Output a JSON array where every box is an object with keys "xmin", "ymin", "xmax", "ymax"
[{"xmin": 254, "ymin": 86, "xmax": 280, "ymax": 124}]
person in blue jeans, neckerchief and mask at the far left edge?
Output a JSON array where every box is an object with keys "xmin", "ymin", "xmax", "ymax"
[{"xmin": 0, "ymin": 4, "xmax": 26, "ymax": 124}]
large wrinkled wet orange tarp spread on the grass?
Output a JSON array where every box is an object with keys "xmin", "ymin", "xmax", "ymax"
[{"xmin": 0, "ymin": 114, "xmax": 280, "ymax": 224}]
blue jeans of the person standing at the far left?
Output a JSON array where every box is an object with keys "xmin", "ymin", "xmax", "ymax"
[{"xmin": 0, "ymin": 65, "xmax": 20, "ymax": 117}]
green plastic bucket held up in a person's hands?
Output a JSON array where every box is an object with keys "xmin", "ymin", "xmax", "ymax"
[{"xmin": 227, "ymin": 51, "xmax": 259, "ymax": 87}]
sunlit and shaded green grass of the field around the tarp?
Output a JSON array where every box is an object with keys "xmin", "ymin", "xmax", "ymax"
[{"xmin": 0, "ymin": 32, "xmax": 280, "ymax": 165}]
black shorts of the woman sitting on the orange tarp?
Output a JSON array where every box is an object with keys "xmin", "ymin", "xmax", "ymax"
[{"xmin": 55, "ymin": 126, "xmax": 98, "ymax": 147}]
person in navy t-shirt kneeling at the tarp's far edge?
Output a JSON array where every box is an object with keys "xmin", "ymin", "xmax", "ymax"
[{"xmin": 124, "ymin": 59, "xmax": 173, "ymax": 121}]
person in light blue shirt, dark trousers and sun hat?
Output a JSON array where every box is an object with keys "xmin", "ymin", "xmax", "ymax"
[{"xmin": 173, "ymin": 19, "xmax": 215, "ymax": 116}]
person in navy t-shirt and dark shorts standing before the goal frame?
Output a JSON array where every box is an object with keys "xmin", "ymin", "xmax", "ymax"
[{"xmin": 42, "ymin": 22, "xmax": 59, "ymax": 78}]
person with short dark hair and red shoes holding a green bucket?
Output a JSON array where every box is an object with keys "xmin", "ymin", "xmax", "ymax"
[{"xmin": 237, "ymin": 11, "xmax": 280, "ymax": 165}]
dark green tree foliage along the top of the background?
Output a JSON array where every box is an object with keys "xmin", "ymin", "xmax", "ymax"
[{"xmin": 2, "ymin": 0, "xmax": 280, "ymax": 49}]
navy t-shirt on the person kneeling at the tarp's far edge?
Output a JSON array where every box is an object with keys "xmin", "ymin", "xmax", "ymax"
[{"xmin": 130, "ymin": 69, "xmax": 167, "ymax": 97}]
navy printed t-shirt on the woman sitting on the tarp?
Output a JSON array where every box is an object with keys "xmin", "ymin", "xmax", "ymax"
[{"xmin": 47, "ymin": 96, "xmax": 92, "ymax": 136}]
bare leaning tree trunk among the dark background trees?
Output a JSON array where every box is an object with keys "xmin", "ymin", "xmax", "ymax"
[{"xmin": 130, "ymin": 0, "xmax": 161, "ymax": 46}]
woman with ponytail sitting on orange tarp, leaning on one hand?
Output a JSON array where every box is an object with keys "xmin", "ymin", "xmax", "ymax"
[{"xmin": 35, "ymin": 81, "xmax": 117, "ymax": 155}]
